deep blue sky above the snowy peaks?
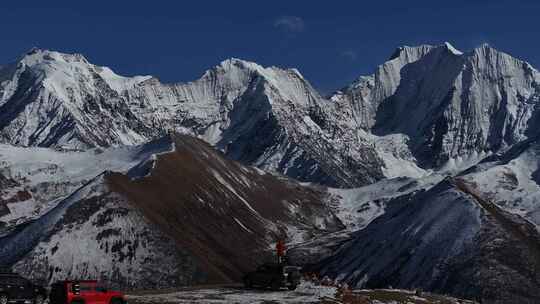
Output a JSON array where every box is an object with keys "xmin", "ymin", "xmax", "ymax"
[{"xmin": 0, "ymin": 0, "xmax": 540, "ymax": 92}]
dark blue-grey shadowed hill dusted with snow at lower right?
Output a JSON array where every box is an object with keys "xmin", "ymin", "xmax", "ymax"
[{"xmin": 319, "ymin": 180, "xmax": 540, "ymax": 303}]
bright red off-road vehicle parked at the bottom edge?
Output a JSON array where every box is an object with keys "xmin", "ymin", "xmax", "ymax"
[{"xmin": 49, "ymin": 281, "xmax": 127, "ymax": 304}]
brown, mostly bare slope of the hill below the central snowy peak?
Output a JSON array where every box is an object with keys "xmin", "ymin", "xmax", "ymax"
[{"xmin": 107, "ymin": 136, "xmax": 343, "ymax": 282}]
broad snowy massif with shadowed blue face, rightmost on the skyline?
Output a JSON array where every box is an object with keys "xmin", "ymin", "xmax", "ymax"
[{"xmin": 331, "ymin": 43, "xmax": 540, "ymax": 167}]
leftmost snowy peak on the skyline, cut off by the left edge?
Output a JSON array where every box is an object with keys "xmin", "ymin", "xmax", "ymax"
[{"xmin": 0, "ymin": 49, "xmax": 155, "ymax": 149}]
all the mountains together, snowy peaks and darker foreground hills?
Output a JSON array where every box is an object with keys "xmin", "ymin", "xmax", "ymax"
[{"xmin": 0, "ymin": 43, "xmax": 540, "ymax": 303}]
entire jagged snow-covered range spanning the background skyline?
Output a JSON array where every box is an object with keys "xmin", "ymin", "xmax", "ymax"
[{"xmin": 0, "ymin": 43, "xmax": 540, "ymax": 187}]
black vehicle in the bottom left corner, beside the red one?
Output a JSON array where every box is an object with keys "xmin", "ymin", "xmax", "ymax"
[{"xmin": 0, "ymin": 272, "xmax": 47, "ymax": 304}]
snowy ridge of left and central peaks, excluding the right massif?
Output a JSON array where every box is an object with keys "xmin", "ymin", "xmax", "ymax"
[{"xmin": 0, "ymin": 50, "xmax": 383, "ymax": 186}]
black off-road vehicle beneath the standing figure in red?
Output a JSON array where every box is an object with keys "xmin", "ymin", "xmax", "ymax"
[{"xmin": 244, "ymin": 263, "xmax": 301, "ymax": 290}]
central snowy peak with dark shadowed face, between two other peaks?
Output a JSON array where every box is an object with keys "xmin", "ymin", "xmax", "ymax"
[{"xmin": 126, "ymin": 59, "xmax": 382, "ymax": 186}]
